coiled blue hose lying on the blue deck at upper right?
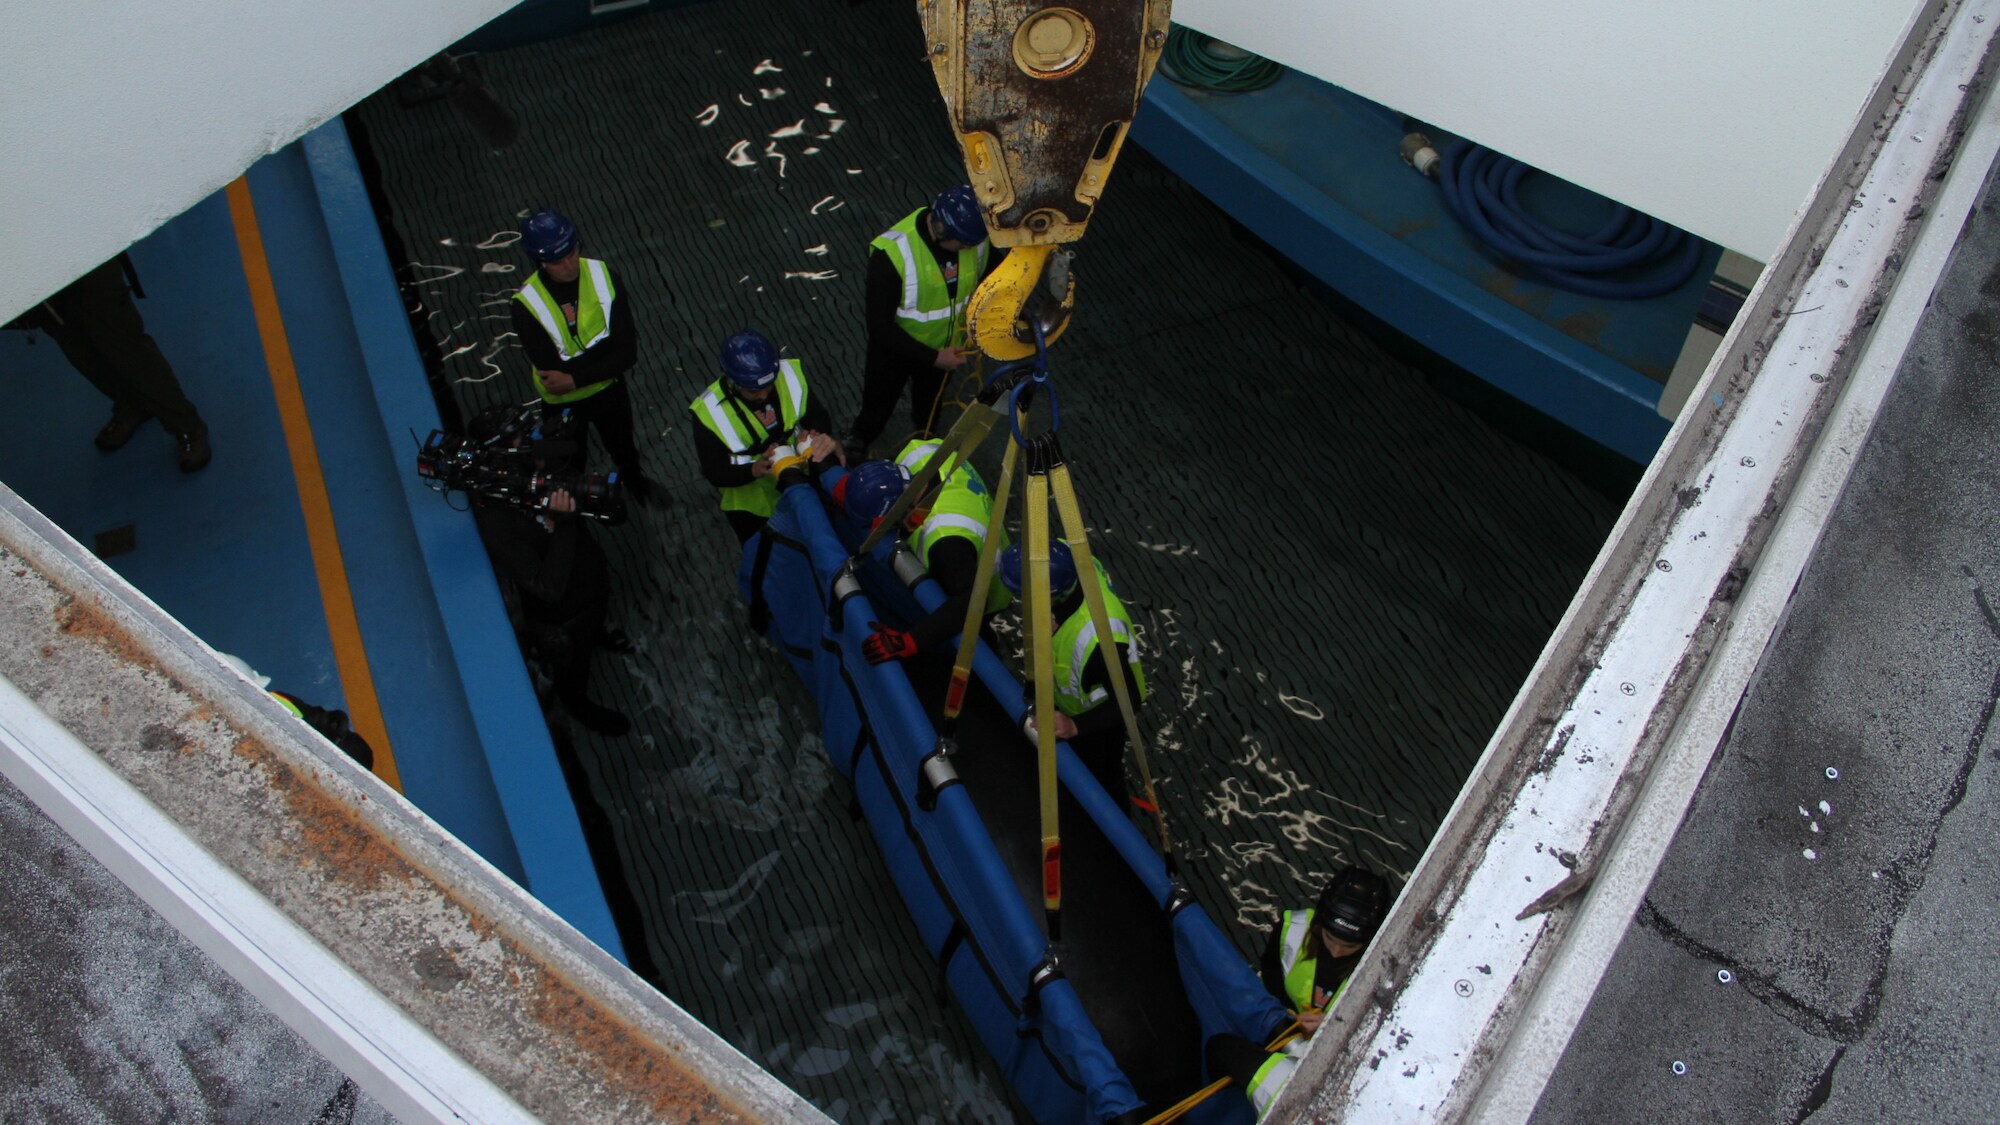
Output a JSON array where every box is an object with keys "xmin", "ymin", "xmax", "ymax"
[{"xmin": 1438, "ymin": 142, "xmax": 1702, "ymax": 300}]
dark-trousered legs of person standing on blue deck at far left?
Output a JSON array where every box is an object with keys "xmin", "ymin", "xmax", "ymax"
[{"xmin": 44, "ymin": 258, "xmax": 206, "ymax": 444}]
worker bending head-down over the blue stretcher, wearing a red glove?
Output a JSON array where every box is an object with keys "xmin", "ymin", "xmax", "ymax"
[{"xmin": 834, "ymin": 438, "xmax": 1014, "ymax": 665}]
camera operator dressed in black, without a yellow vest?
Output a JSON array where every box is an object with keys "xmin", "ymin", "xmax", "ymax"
[{"xmin": 470, "ymin": 412, "xmax": 632, "ymax": 737}]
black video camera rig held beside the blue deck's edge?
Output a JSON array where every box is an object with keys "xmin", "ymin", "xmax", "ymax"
[{"xmin": 416, "ymin": 402, "xmax": 626, "ymax": 522}]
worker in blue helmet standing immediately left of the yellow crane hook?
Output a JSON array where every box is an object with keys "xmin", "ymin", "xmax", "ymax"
[{"xmin": 844, "ymin": 184, "xmax": 1006, "ymax": 460}]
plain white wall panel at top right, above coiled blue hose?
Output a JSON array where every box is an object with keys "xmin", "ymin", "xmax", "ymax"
[{"xmin": 1174, "ymin": 0, "xmax": 1922, "ymax": 262}]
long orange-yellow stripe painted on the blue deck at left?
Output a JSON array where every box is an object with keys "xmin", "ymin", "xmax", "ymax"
[{"xmin": 228, "ymin": 178, "xmax": 402, "ymax": 793}]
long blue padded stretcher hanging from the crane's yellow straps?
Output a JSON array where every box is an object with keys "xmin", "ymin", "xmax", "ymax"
[{"xmin": 738, "ymin": 468, "xmax": 1288, "ymax": 1123}]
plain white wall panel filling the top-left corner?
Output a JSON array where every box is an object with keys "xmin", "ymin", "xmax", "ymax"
[{"xmin": 0, "ymin": 0, "xmax": 514, "ymax": 320}]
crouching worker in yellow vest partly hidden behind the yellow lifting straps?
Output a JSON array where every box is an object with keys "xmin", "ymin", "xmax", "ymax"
[{"xmin": 1000, "ymin": 538, "xmax": 1146, "ymax": 809}]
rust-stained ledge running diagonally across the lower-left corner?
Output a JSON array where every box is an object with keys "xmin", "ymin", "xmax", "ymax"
[{"xmin": 0, "ymin": 486, "xmax": 826, "ymax": 1123}]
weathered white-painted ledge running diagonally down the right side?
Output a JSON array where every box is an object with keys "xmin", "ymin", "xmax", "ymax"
[{"xmin": 1272, "ymin": 0, "xmax": 1996, "ymax": 1121}]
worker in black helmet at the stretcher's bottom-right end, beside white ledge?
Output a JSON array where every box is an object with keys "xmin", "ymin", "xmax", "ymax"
[{"xmin": 1204, "ymin": 867, "xmax": 1390, "ymax": 1121}]
